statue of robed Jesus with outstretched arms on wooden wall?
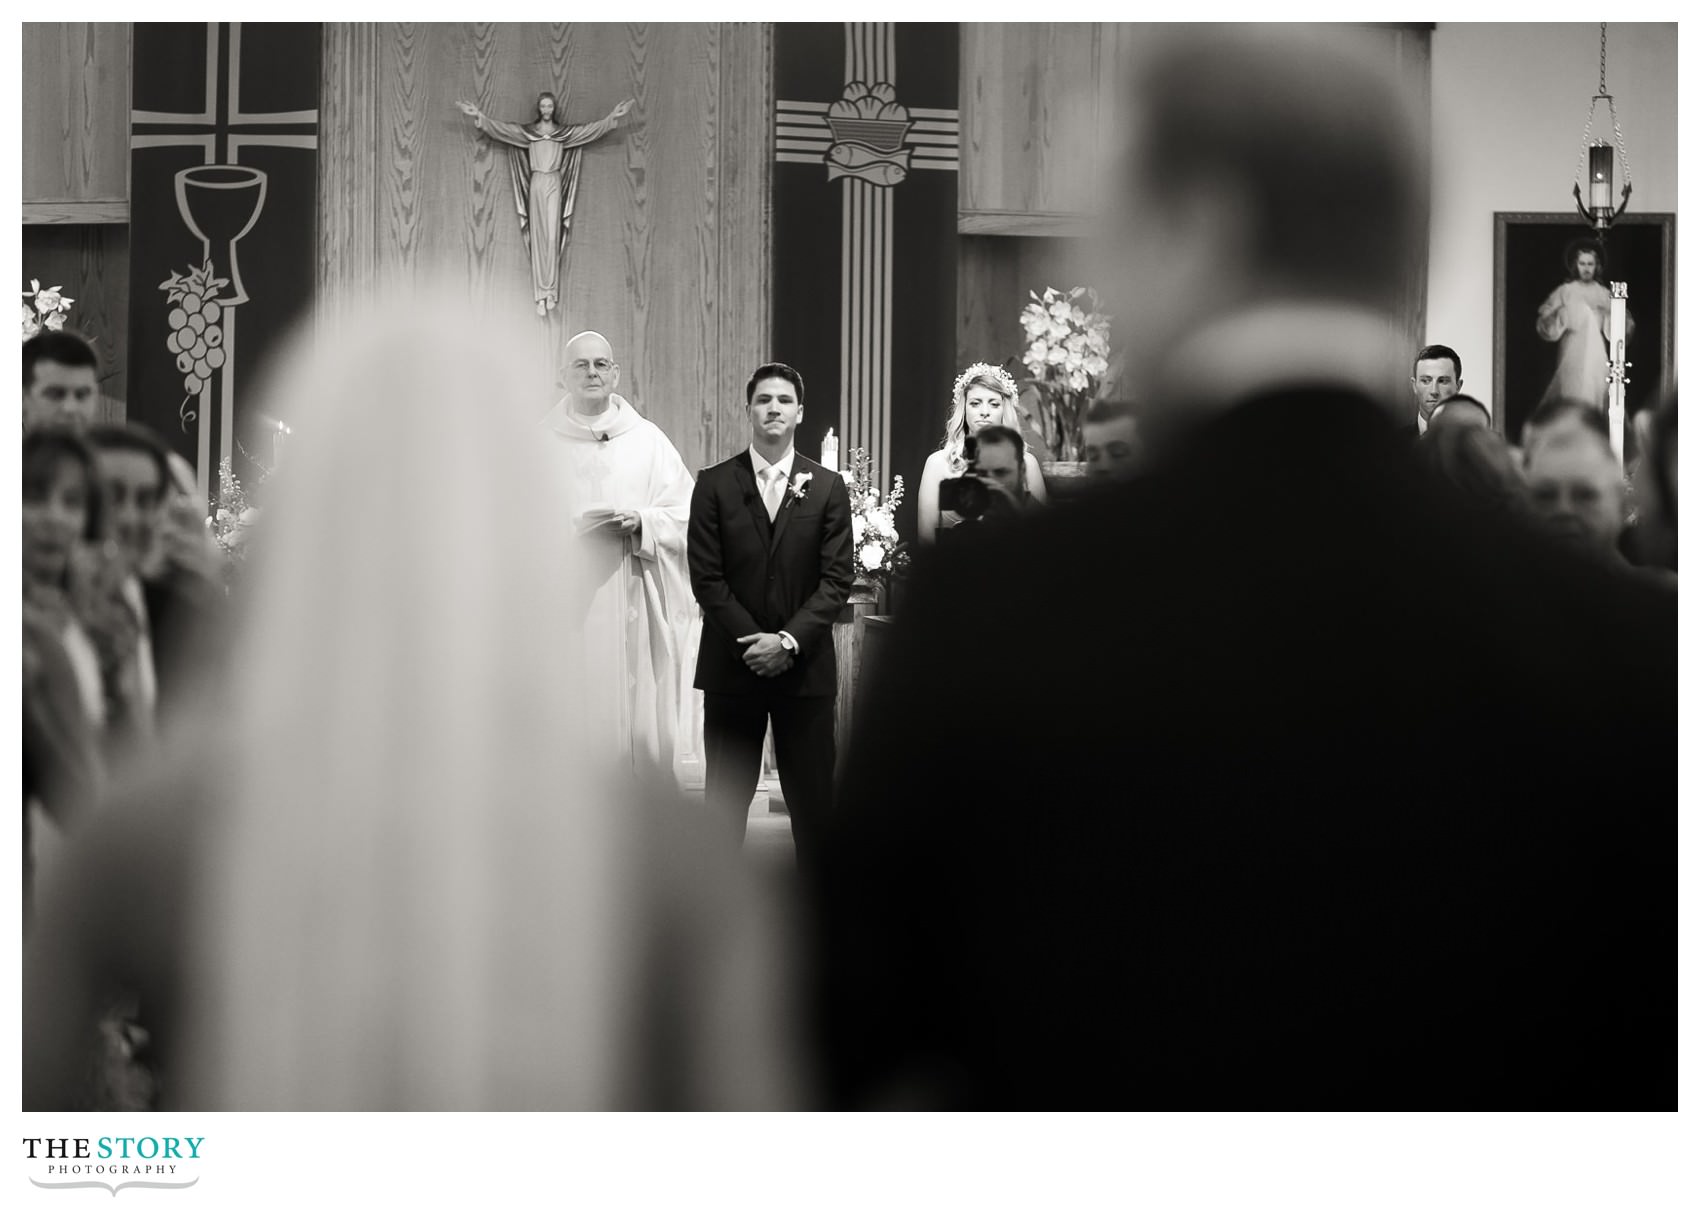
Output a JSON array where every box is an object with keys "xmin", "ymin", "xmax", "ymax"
[{"xmin": 456, "ymin": 93, "xmax": 634, "ymax": 316}]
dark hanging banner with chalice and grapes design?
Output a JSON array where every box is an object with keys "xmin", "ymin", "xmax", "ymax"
[{"xmin": 128, "ymin": 22, "xmax": 321, "ymax": 498}]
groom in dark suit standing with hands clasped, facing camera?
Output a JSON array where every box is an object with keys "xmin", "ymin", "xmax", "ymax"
[{"xmin": 689, "ymin": 362, "xmax": 855, "ymax": 861}]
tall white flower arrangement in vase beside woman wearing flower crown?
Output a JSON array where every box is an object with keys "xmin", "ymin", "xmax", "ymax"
[{"xmin": 1022, "ymin": 287, "xmax": 1110, "ymax": 460}]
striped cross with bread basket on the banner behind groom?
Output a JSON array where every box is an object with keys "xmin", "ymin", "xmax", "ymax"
[{"xmin": 774, "ymin": 22, "xmax": 961, "ymax": 492}]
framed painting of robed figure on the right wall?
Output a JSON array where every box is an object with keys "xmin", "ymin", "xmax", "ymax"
[{"xmin": 1493, "ymin": 211, "xmax": 1676, "ymax": 442}]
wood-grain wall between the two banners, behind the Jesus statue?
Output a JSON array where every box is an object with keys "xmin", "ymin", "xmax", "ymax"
[{"xmin": 320, "ymin": 24, "xmax": 774, "ymax": 467}]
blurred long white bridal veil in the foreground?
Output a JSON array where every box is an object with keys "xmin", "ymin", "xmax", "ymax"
[{"xmin": 184, "ymin": 290, "xmax": 632, "ymax": 1109}]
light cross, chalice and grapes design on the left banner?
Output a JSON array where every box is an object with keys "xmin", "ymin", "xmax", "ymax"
[{"xmin": 129, "ymin": 22, "xmax": 318, "ymax": 496}]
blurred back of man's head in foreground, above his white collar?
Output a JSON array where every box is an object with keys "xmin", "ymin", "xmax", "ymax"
[{"xmin": 1112, "ymin": 27, "xmax": 1426, "ymax": 362}]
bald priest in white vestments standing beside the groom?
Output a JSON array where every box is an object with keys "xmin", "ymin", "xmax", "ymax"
[{"xmin": 544, "ymin": 333, "xmax": 697, "ymax": 773}]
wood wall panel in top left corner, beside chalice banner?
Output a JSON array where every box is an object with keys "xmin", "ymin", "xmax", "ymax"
[{"xmin": 22, "ymin": 22, "xmax": 129, "ymax": 223}]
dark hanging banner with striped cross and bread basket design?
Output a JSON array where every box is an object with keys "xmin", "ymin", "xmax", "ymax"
[{"xmin": 774, "ymin": 22, "xmax": 961, "ymax": 537}]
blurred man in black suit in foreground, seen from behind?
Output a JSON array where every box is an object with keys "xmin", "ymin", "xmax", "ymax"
[{"xmin": 819, "ymin": 31, "xmax": 1676, "ymax": 1109}]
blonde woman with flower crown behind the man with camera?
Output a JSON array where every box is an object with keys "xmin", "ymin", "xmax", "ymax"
[{"xmin": 916, "ymin": 362, "xmax": 1046, "ymax": 545}]
